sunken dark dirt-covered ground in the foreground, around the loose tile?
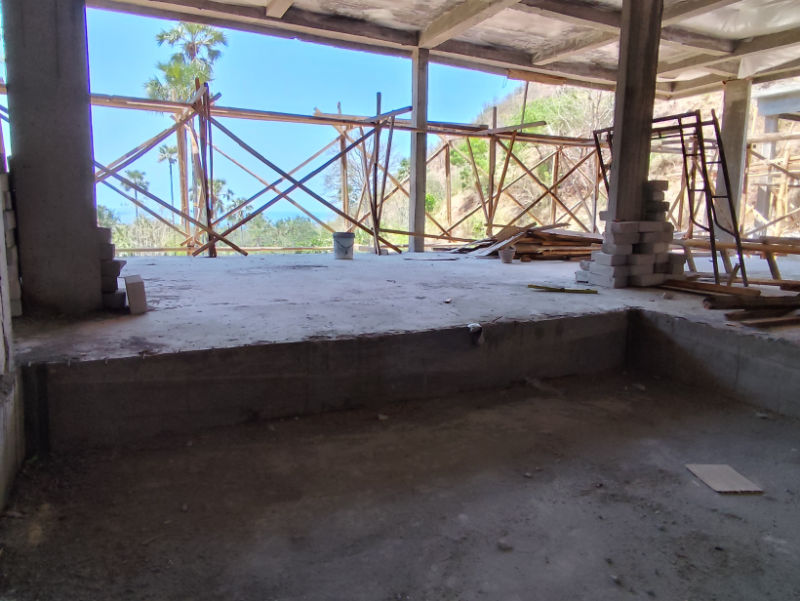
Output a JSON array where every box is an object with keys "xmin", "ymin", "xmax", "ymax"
[{"xmin": 0, "ymin": 375, "xmax": 800, "ymax": 601}]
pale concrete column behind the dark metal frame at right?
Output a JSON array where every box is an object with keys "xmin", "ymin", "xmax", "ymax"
[{"xmin": 715, "ymin": 79, "xmax": 752, "ymax": 240}]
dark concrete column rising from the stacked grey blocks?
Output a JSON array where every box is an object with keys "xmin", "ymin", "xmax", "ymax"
[{"xmin": 608, "ymin": 0, "xmax": 664, "ymax": 221}]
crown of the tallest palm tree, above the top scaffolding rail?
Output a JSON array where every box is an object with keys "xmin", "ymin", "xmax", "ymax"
[{"xmin": 145, "ymin": 23, "xmax": 228, "ymax": 102}]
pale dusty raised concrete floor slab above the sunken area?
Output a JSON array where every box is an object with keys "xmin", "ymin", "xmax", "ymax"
[{"xmin": 14, "ymin": 253, "xmax": 800, "ymax": 363}]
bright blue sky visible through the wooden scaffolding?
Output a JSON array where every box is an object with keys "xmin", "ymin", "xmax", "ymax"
[{"xmin": 10, "ymin": 9, "xmax": 519, "ymax": 221}]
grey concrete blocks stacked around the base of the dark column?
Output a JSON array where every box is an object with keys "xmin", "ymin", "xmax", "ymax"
[{"xmin": 575, "ymin": 181, "xmax": 683, "ymax": 288}]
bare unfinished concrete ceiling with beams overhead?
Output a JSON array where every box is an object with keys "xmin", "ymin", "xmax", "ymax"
[{"xmin": 87, "ymin": 0, "xmax": 800, "ymax": 98}]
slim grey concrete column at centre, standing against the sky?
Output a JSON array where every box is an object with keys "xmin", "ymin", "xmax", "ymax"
[{"xmin": 408, "ymin": 48, "xmax": 429, "ymax": 252}]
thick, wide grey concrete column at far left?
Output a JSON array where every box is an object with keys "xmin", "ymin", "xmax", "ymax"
[{"xmin": 2, "ymin": 0, "xmax": 101, "ymax": 314}]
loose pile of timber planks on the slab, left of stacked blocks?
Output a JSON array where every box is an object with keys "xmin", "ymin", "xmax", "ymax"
[{"xmin": 451, "ymin": 224, "xmax": 603, "ymax": 261}]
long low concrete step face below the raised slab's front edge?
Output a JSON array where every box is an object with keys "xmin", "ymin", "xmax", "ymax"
[{"xmin": 37, "ymin": 312, "xmax": 627, "ymax": 451}]
